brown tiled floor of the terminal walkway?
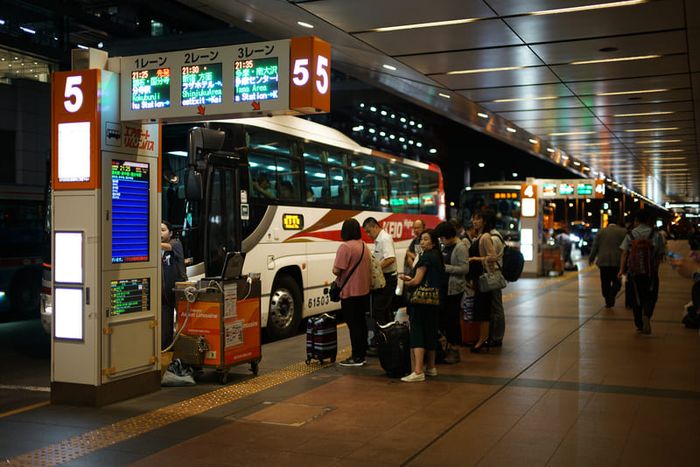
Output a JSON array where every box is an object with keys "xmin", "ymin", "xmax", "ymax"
[{"xmin": 0, "ymin": 239, "xmax": 700, "ymax": 467}]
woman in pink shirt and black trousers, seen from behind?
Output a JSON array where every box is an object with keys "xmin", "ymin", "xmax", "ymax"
[{"xmin": 333, "ymin": 218, "xmax": 372, "ymax": 366}]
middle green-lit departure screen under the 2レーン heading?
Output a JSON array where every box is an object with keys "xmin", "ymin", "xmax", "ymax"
[{"xmin": 181, "ymin": 63, "xmax": 224, "ymax": 106}]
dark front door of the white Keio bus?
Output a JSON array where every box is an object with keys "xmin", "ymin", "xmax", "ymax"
[{"xmin": 203, "ymin": 153, "xmax": 241, "ymax": 276}]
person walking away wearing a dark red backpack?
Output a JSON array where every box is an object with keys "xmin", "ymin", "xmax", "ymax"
[{"xmin": 617, "ymin": 209, "xmax": 664, "ymax": 335}]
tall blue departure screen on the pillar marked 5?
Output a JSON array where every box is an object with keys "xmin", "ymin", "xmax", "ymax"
[{"xmin": 112, "ymin": 160, "xmax": 150, "ymax": 263}]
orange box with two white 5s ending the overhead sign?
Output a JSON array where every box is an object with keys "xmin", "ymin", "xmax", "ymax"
[{"xmin": 289, "ymin": 37, "xmax": 331, "ymax": 113}]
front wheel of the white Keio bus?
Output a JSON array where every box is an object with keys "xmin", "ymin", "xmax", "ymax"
[{"xmin": 267, "ymin": 274, "xmax": 301, "ymax": 340}]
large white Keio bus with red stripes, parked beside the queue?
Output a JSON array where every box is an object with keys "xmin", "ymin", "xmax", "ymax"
[{"xmin": 163, "ymin": 117, "xmax": 445, "ymax": 339}]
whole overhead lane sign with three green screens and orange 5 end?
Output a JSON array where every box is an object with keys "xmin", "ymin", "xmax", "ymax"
[{"xmin": 120, "ymin": 37, "xmax": 331, "ymax": 123}]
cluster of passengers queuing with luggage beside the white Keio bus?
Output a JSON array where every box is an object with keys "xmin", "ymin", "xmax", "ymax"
[{"xmin": 333, "ymin": 209, "xmax": 505, "ymax": 382}]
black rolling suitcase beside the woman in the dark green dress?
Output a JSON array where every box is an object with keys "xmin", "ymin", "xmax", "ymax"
[{"xmin": 376, "ymin": 322, "xmax": 411, "ymax": 378}]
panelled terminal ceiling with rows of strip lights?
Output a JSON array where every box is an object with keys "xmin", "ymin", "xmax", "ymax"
[{"xmin": 180, "ymin": 0, "xmax": 700, "ymax": 203}]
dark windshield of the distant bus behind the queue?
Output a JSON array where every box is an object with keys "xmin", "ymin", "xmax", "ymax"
[{"xmin": 460, "ymin": 187, "xmax": 520, "ymax": 241}]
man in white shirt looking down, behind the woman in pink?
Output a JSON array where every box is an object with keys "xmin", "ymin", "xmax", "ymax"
[{"xmin": 362, "ymin": 217, "xmax": 398, "ymax": 324}]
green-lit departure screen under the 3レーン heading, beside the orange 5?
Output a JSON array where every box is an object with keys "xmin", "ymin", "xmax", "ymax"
[{"xmin": 233, "ymin": 57, "xmax": 280, "ymax": 102}]
